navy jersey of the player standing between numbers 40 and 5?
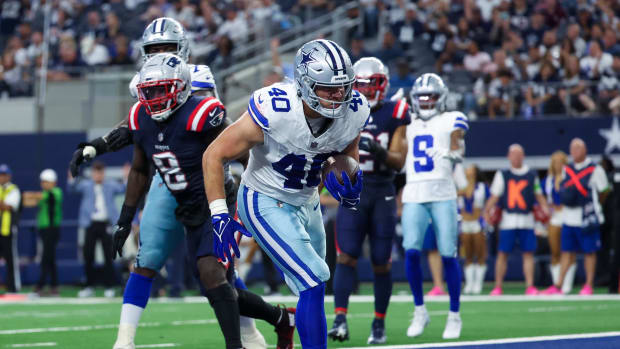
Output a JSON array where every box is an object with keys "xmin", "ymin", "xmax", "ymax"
[{"xmin": 360, "ymin": 99, "xmax": 411, "ymax": 182}]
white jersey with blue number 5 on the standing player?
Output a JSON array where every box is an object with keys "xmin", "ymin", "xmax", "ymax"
[{"xmin": 403, "ymin": 111, "xmax": 469, "ymax": 203}]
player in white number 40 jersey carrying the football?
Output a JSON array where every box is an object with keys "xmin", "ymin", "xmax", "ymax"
[{"xmin": 203, "ymin": 40, "xmax": 370, "ymax": 348}]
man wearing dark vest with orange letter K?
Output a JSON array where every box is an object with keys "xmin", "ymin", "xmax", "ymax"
[{"xmin": 485, "ymin": 144, "xmax": 548, "ymax": 296}]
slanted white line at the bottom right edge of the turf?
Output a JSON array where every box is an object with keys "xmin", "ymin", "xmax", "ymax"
[{"xmin": 347, "ymin": 332, "xmax": 620, "ymax": 349}]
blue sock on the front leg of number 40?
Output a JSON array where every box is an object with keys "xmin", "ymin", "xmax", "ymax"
[{"xmin": 295, "ymin": 283, "xmax": 327, "ymax": 349}]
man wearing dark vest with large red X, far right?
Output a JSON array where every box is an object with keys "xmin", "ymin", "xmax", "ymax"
[{"xmin": 543, "ymin": 138, "xmax": 610, "ymax": 295}]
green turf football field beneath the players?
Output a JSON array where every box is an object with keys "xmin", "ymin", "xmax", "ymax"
[{"xmin": 0, "ymin": 285, "xmax": 620, "ymax": 349}]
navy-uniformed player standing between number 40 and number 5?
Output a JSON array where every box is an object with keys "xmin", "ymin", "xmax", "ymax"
[{"xmin": 329, "ymin": 57, "xmax": 411, "ymax": 344}]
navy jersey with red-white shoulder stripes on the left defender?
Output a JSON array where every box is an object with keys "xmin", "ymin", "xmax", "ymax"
[{"xmin": 128, "ymin": 96, "xmax": 226, "ymax": 225}]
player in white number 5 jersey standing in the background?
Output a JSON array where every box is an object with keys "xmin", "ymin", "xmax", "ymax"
[{"xmin": 402, "ymin": 74, "xmax": 469, "ymax": 339}]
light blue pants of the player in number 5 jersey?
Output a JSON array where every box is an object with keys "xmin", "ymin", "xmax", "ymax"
[{"xmin": 402, "ymin": 200, "xmax": 458, "ymax": 257}]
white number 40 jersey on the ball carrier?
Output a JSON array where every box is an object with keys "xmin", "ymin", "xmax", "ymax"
[{"xmin": 242, "ymin": 83, "xmax": 370, "ymax": 206}]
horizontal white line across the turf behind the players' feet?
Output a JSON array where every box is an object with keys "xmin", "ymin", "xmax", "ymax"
[{"xmin": 0, "ymin": 294, "xmax": 620, "ymax": 305}]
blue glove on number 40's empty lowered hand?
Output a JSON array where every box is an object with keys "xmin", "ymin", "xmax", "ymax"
[{"xmin": 211, "ymin": 213, "xmax": 252, "ymax": 262}]
